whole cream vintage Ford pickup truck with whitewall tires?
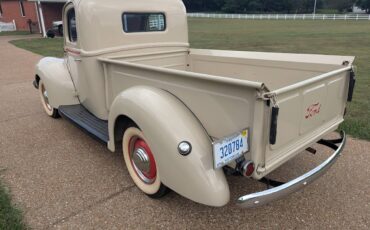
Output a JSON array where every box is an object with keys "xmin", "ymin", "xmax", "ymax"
[{"xmin": 33, "ymin": 0, "xmax": 355, "ymax": 207}]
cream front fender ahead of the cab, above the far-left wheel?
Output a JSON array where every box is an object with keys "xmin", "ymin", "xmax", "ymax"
[{"xmin": 35, "ymin": 57, "xmax": 79, "ymax": 108}]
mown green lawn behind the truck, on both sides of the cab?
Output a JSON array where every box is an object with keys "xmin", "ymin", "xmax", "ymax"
[{"xmin": 12, "ymin": 18, "xmax": 370, "ymax": 140}]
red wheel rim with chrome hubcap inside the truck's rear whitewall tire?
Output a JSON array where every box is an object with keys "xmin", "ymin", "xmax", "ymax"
[{"xmin": 129, "ymin": 137, "xmax": 157, "ymax": 184}]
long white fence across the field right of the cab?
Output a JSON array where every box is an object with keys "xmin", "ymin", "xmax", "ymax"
[{"xmin": 188, "ymin": 13, "xmax": 370, "ymax": 21}]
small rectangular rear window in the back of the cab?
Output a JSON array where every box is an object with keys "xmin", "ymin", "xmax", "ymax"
[{"xmin": 122, "ymin": 13, "xmax": 166, "ymax": 33}]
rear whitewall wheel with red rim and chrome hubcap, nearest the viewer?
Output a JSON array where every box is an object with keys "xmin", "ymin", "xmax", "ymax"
[{"xmin": 122, "ymin": 126, "xmax": 169, "ymax": 198}]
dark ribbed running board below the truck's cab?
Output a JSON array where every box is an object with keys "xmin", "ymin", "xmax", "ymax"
[{"xmin": 58, "ymin": 105, "xmax": 109, "ymax": 143}]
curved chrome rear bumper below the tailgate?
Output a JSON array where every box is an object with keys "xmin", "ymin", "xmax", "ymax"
[{"xmin": 237, "ymin": 131, "xmax": 346, "ymax": 208}]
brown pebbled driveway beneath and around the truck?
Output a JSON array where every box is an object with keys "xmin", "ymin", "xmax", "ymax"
[{"xmin": 0, "ymin": 37, "xmax": 370, "ymax": 229}]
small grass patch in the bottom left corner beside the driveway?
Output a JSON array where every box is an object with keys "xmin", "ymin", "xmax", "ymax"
[{"xmin": 0, "ymin": 181, "xmax": 27, "ymax": 230}]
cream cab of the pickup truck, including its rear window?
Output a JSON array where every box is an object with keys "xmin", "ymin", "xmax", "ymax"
[{"xmin": 63, "ymin": 0, "xmax": 189, "ymax": 120}]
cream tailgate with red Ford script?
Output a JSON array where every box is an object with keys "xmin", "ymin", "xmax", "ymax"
[{"xmin": 264, "ymin": 66, "xmax": 354, "ymax": 174}]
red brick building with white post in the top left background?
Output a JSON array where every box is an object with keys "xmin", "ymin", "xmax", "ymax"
[{"xmin": 0, "ymin": 0, "xmax": 67, "ymax": 33}]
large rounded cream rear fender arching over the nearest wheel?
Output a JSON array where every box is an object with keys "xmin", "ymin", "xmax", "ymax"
[{"xmin": 109, "ymin": 86, "xmax": 230, "ymax": 206}]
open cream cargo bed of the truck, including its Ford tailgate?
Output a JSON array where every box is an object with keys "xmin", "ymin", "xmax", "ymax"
[{"xmin": 100, "ymin": 49, "xmax": 354, "ymax": 177}]
